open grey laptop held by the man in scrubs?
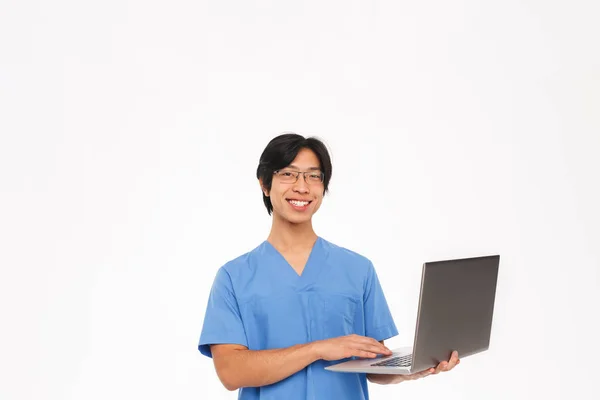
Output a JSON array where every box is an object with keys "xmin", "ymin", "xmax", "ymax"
[{"xmin": 325, "ymin": 255, "xmax": 500, "ymax": 375}]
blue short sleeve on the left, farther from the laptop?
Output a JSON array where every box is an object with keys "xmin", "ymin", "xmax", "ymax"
[{"xmin": 198, "ymin": 268, "xmax": 248, "ymax": 357}]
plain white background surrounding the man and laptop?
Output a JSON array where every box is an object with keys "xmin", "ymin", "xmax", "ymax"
[{"xmin": 0, "ymin": 0, "xmax": 600, "ymax": 400}]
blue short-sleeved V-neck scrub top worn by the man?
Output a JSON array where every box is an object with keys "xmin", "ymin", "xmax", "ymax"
[{"xmin": 198, "ymin": 237, "xmax": 398, "ymax": 400}]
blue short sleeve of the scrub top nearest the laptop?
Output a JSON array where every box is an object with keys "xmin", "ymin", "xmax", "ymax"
[{"xmin": 363, "ymin": 263, "xmax": 398, "ymax": 341}]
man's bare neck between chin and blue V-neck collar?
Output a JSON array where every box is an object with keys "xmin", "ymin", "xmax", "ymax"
[{"xmin": 267, "ymin": 214, "xmax": 317, "ymax": 251}]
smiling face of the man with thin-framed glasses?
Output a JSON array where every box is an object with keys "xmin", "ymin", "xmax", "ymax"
[{"xmin": 267, "ymin": 149, "xmax": 324, "ymax": 224}]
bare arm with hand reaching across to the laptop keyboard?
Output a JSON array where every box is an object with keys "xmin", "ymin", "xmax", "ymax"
[{"xmin": 210, "ymin": 335, "xmax": 392, "ymax": 390}]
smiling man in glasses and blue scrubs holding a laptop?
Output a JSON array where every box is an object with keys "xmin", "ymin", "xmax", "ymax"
[{"xmin": 198, "ymin": 134, "xmax": 459, "ymax": 400}]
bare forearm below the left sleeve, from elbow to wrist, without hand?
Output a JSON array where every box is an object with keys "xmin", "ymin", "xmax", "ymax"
[{"xmin": 217, "ymin": 343, "xmax": 319, "ymax": 390}]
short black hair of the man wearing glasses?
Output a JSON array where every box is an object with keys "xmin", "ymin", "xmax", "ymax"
[{"xmin": 256, "ymin": 133, "xmax": 332, "ymax": 215}]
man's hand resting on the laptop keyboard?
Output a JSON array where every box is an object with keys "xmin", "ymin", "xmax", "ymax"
[{"xmin": 313, "ymin": 335, "xmax": 392, "ymax": 361}]
